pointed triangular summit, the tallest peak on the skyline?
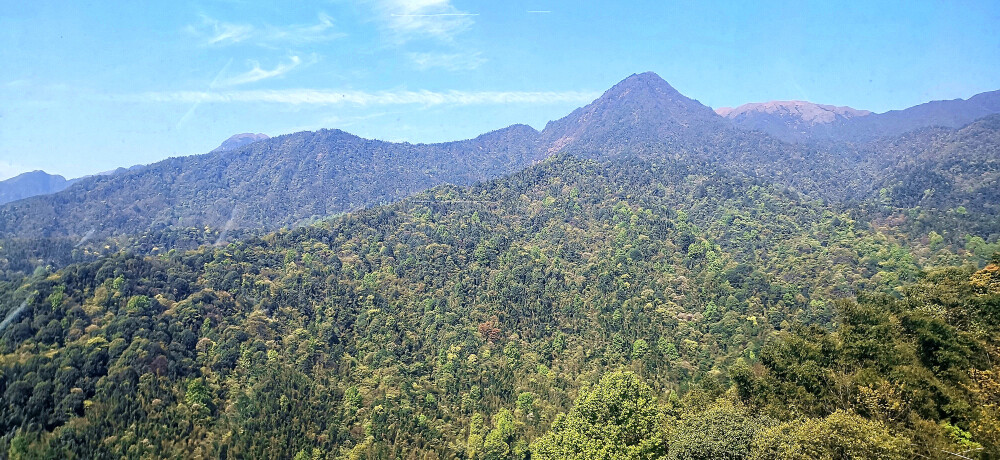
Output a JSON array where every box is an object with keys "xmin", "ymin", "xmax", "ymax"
[{"xmin": 542, "ymin": 72, "xmax": 726, "ymax": 156}]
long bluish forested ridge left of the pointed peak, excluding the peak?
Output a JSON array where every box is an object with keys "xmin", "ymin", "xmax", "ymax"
[{"xmin": 0, "ymin": 125, "xmax": 538, "ymax": 236}]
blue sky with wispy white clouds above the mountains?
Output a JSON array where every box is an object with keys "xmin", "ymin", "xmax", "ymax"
[{"xmin": 0, "ymin": 0, "xmax": 1000, "ymax": 179}]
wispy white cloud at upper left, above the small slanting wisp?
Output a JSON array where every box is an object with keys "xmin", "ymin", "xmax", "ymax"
[{"xmin": 185, "ymin": 13, "xmax": 345, "ymax": 46}]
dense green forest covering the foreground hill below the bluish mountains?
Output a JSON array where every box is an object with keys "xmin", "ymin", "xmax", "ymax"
[{"xmin": 0, "ymin": 155, "xmax": 1000, "ymax": 459}]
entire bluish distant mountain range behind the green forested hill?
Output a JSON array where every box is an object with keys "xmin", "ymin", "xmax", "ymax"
[{"xmin": 0, "ymin": 72, "xmax": 1000, "ymax": 244}]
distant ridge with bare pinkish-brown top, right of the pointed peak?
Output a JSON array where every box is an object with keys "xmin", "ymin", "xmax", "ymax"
[{"xmin": 716, "ymin": 91, "xmax": 1000, "ymax": 142}]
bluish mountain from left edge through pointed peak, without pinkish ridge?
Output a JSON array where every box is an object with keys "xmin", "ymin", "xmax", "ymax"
[{"xmin": 0, "ymin": 72, "xmax": 820, "ymax": 243}]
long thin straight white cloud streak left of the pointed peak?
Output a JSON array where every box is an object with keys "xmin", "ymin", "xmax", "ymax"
[{"xmin": 133, "ymin": 89, "xmax": 600, "ymax": 106}]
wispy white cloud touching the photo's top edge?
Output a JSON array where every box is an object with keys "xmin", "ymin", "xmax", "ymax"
[{"xmin": 376, "ymin": 0, "xmax": 478, "ymax": 42}]
